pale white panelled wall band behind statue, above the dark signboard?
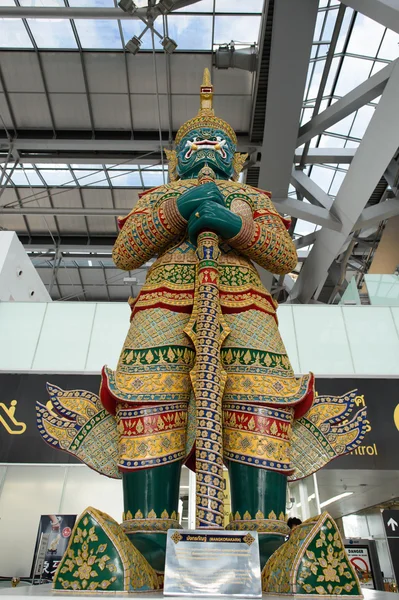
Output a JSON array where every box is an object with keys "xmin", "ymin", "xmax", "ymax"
[{"xmin": 0, "ymin": 304, "xmax": 399, "ymax": 376}]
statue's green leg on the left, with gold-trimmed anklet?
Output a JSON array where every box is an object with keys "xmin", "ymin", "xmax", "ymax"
[{"xmin": 122, "ymin": 461, "xmax": 182, "ymax": 572}]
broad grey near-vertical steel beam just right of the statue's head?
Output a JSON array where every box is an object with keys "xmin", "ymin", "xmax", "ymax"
[{"xmin": 259, "ymin": 0, "xmax": 318, "ymax": 197}]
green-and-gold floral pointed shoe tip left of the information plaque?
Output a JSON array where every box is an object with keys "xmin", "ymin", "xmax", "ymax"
[{"xmin": 53, "ymin": 507, "xmax": 160, "ymax": 594}]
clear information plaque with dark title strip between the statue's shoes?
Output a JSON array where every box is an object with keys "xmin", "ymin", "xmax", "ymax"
[{"xmin": 164, "ymin": 529, "xmax": 262, "ymax": 598}]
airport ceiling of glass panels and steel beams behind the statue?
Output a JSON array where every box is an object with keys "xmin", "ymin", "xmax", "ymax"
[{"xmin": 0, "ymin": 0, "xmax": 399, "ymax": 302}]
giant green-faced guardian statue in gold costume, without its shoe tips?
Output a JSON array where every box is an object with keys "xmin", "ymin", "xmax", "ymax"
[{"xmin": 38, "ymin": 70, "xmax": 365, "ymax": 594}]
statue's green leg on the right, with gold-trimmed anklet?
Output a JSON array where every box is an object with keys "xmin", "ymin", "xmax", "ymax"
[{"xmin": 228, "ymin": 461, "xmax": 287, "ymax": 568}]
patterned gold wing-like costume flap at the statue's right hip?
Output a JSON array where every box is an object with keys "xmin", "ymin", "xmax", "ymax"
[{"xmin": 289, "ymin": 390, "xmax": 368, "ymax": 481}]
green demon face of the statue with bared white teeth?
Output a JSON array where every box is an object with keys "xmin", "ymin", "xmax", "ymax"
[{"xmin": 176, "ymin": 127, "xmax": 236, "ymax": 179}]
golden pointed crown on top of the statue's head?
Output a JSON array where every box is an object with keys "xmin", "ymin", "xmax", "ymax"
[{"xmin": 175, "ymin": 69, "xmax": 237, "ymax": 144}]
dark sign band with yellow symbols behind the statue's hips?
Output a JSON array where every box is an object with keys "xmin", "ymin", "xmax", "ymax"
[{"xmin": 0, "ymin": 374, "xmax": 399, "ymax": 469}]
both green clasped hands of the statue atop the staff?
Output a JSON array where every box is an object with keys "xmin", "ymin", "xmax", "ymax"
[{"xmin": 177, "ymin": 183, "xmax": 242, "ymax": 244}]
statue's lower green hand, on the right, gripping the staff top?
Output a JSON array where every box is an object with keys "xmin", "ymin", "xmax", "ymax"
[{"xmin": 188, "ymin": 200, "xmax": 242, "ymax": 244}]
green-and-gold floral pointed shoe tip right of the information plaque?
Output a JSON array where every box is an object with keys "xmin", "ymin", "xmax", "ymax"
[{"xmin": 262, "ymin": 512, "xmax": 363, "ymax": 598}]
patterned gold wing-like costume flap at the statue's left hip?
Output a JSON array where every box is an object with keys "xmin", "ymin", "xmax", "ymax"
[{"xmin": 36, "ymin": 383, "xmax": 121, "ymax": 479}]
